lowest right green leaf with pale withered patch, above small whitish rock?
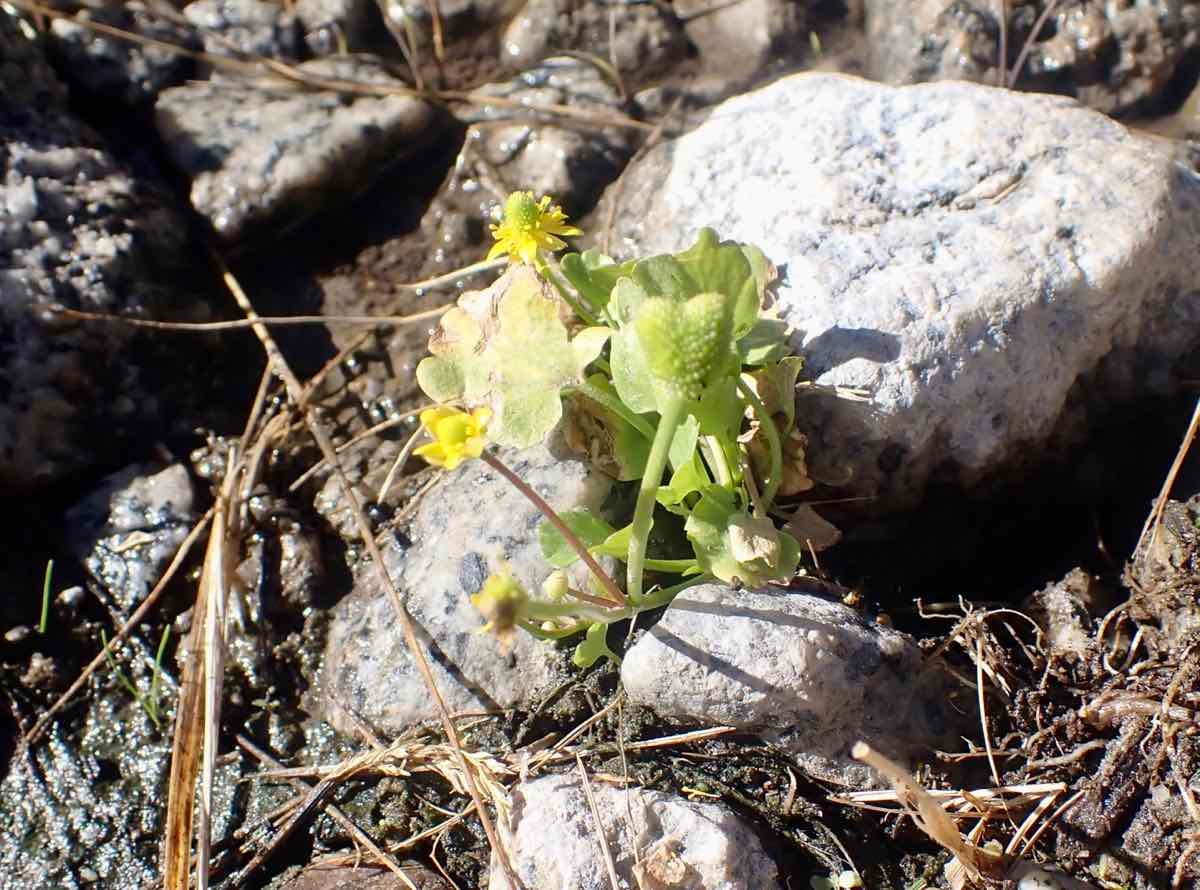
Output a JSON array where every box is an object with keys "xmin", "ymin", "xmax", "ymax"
[{"xmin": 684, "ymin": 486, "xmax": 800, "ymax": 587}]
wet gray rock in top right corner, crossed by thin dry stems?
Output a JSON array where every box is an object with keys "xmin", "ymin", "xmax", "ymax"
[{"xmin": 865, "ymin": 0, "xmax": 1200, "ymax": 115}]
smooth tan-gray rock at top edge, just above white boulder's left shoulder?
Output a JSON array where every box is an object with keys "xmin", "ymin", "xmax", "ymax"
[{"xmin": 674, "ymin": 0, "xmax": 809, "ymax": 84}]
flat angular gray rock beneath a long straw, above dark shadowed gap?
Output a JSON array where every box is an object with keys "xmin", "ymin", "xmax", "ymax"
[{"xmin": 155, "ymin": 56, "xmax": 438, "ymax": 241}]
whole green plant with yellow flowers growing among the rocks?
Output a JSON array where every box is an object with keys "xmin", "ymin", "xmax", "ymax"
[{"xmin": 416, "ymin": 192, "xmax": 804, "ymax": 666}]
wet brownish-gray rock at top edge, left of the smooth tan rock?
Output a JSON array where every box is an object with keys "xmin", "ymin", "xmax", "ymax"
[{"xmin": 500, "ymin": 0, "xmax": 688, "ymax": 77}]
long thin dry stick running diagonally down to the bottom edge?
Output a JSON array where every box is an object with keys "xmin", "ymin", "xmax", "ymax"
[{"xmin": 215, "ymin": 257, "xmax": 521, "ymax": 890}]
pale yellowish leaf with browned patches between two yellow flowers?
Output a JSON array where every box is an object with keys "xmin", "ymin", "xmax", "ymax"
[{"xmin": 416, "ymin": 265, "xmax": 611, "ymax": 447}]
